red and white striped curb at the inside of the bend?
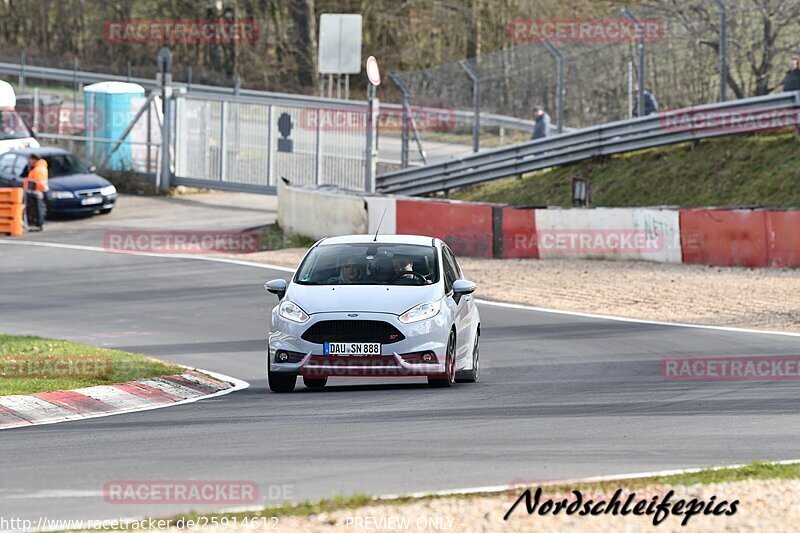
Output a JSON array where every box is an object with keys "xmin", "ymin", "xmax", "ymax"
[{"xmin": 0, "ymin": 369, "xmax": 250, "ymax": 430}]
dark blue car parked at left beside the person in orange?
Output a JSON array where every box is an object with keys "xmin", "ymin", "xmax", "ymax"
[{"xmin": 0, "ymin": 148, "xmax": 117, "ymax": 214}]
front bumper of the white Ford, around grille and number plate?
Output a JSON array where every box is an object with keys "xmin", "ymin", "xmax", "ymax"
[{"xmin": 268, "ymin": 310, "xmax": 449, "ymax": 377}]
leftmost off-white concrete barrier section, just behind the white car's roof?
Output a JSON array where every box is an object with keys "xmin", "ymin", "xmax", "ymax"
[{"xmin": 278, "ymin": 184, "xmax": 368, "ymax": 239}]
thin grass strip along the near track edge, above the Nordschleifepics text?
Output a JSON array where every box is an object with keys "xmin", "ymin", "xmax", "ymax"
[{"xmin": 145, "ymin": 461, "xmax": 800, "ymax": 522}]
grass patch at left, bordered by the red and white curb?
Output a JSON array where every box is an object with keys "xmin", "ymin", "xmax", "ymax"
[{"xmin": 0, "ymin": 333, "xmax": 184, "ymax": 396}]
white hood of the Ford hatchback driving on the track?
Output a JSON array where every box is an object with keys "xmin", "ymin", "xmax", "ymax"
[{"xmin": 286, "ymin": 283, "xmax": 444, "ymax": 315}]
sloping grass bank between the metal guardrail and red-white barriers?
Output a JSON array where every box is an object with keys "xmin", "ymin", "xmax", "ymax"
[{"xmin": 450, "ymin": 133, "xmax": 800, "ymax": 207}]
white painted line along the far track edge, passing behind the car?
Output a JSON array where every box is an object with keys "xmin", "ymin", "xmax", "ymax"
[{"xmin": 0, "ymin": 239, "xmax": 800, "ymax": 337}]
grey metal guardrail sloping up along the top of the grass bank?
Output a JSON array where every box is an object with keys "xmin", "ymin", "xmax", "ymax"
[{"xmin": 376, "ymin": 92, "xmax": 800, "ymax": 195}]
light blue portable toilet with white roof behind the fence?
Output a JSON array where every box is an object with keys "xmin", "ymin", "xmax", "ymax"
[{"xmin": 83, "ymin": 81, "xmax": 144, "ymax": 170}]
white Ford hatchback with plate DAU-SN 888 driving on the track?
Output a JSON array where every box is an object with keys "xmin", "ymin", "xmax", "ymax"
[{"xmin": 265, "ymin": 235, "xmax": 481, "ymax": 392}]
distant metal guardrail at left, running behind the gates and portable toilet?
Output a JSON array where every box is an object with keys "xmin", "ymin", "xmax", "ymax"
[{"xmin": 0, "ymin": 62, "xmax": 534, "ymax": 132}]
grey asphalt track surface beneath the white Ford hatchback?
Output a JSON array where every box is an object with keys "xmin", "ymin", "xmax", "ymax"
[{"xmin": 0, "ymin": 242, "xmax": 800, "ymax": 520}]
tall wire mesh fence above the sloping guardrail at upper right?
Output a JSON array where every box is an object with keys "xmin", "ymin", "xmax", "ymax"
[{"xmin": 390, "ymin": 0, "xmax": 800, "ymax": 128}]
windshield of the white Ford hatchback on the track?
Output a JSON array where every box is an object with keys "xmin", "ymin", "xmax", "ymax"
[{"xmin": 294, "ymin": 243, "xmax": 439, "ymax": 285}]
